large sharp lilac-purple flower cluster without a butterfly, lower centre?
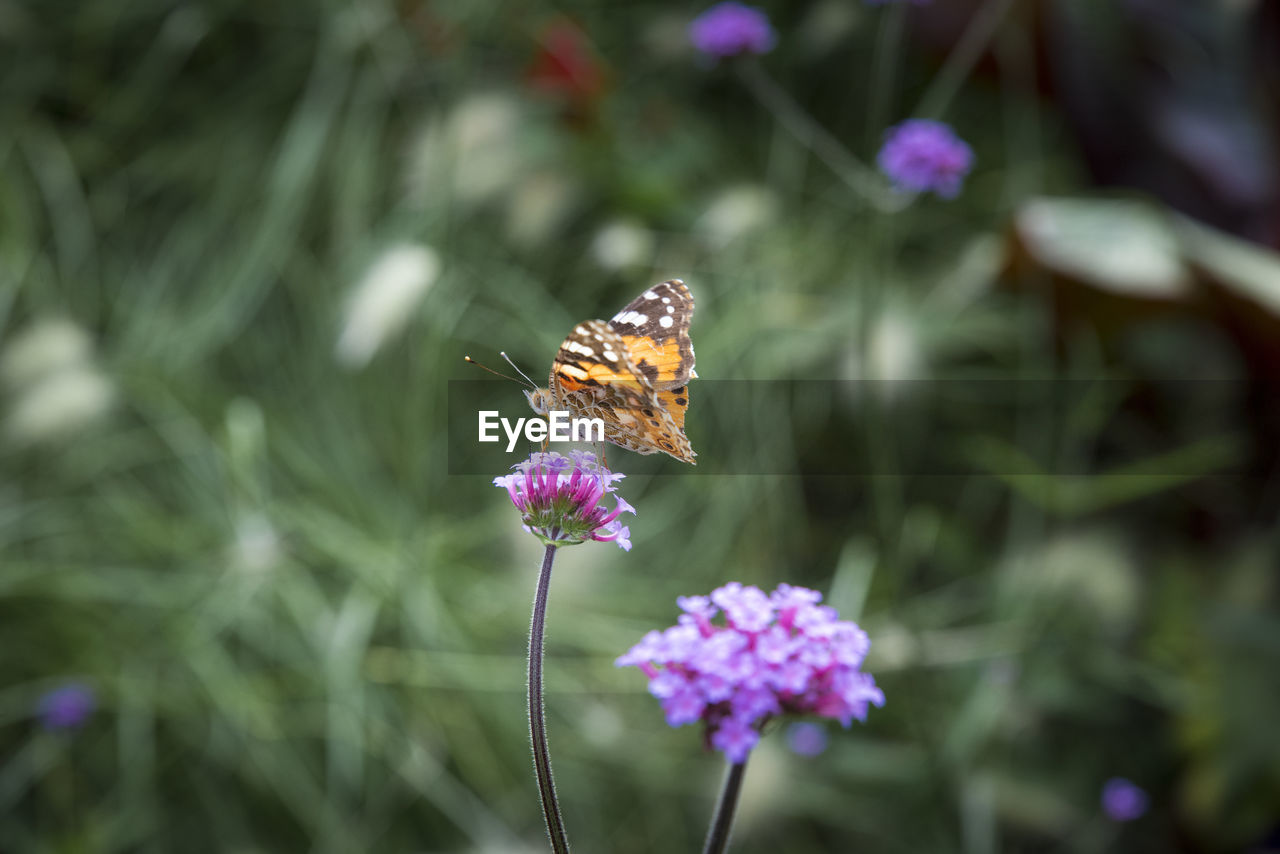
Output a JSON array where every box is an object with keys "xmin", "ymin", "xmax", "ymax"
[{"xmin": 616, "ymin": 581, "xmax": 884, "ymax": 763}]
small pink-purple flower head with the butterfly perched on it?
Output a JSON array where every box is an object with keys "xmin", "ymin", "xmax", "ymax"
[{"xmin": 493, "ymin": 451, "xmax": 636, "ymax": 552}]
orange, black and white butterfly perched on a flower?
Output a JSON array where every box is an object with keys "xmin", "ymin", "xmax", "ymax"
[{"xmin": 525, "ymin": 279, "xmax": 698, "ymax": 465}]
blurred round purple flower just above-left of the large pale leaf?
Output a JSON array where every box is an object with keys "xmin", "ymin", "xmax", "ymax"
[{"xmin": 877, "ymin": 119, "xmax": 973, "ymax": 198}]
